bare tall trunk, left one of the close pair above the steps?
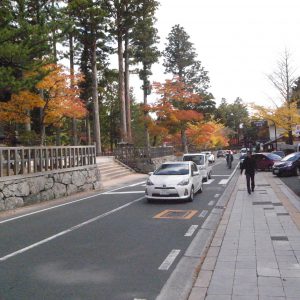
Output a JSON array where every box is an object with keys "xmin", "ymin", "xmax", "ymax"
[{"xmin": 118, "ymin": 32, "xmax": 127, "ymax": 141}]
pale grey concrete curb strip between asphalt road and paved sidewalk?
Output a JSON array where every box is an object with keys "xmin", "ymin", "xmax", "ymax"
[{"xmin": 156, "ymin": 167, "xmax": 239, "ymax": 300}]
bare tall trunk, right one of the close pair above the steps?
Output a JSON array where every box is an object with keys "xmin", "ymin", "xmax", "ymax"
[{"xmin": 124, "ymin": 31, "xmax": 132, "ymax": 143}]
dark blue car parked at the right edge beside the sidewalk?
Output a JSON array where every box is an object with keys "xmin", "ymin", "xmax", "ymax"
[{"xmin": 272, "ymin": 152, "xmax": 300, "ymax": 176}]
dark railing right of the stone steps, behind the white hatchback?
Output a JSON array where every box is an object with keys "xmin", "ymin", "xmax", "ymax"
[{"xmin": 114, "ymin": 146, "xmax": 174, "ymax": 167}]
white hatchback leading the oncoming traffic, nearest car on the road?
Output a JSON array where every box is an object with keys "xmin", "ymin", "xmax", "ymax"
[{"xmin": 145, "ymin": 161, "xmax": 202, "ymax": 201}]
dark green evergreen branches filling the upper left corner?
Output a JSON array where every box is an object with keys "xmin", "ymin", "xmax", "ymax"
[{"xmin": 0, "ymin": 0, "xmax": 51, "ymax": 101}]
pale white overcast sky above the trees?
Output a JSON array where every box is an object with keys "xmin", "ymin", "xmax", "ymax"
[{"xmin": 131, "ymin": 0, "xmax": 300, "ymax": 106}]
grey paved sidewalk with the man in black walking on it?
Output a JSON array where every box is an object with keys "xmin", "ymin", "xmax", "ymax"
[{"xmin": 189, "ymin": 172, "xmax": 300, "ymax": 300}]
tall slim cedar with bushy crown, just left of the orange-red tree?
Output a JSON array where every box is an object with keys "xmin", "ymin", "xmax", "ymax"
[{"xmin": 132, "ymin": 0, "xmax": 160, "ymax": 147}]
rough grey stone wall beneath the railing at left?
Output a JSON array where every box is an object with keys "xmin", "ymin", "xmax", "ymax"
[{"xmin": 0, "ymin": 166, "xmax": 101, "ymax": 211}]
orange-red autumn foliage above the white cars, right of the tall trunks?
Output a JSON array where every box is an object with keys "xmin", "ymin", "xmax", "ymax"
[{"xmin": 147, "ymin": 78, "xmax": 228, "ymax": 152}]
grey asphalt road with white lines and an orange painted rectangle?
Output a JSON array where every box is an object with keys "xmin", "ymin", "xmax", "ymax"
[{"xmin": 0, "ymin": 158, "xmax": 238, "ymax": 300}]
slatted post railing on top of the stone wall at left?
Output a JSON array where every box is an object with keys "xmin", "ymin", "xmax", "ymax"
[{"xmin": 0, "ymin": 146, "xmax": 96, "ymax": 177}]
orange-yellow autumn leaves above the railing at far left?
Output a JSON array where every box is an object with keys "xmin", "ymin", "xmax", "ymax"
[{"xmin": 0, "ymin": 65, "xmax": 86, "ymax": 125}]
